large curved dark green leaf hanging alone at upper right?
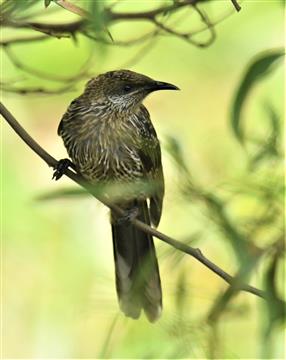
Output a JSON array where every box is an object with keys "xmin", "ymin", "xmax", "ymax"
[{"xmin": 231, "ymin": 48, "xmax": 284, "ymax": 143}]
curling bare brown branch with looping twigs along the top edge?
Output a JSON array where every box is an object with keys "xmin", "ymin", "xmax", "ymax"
[{"xmin": 2, "ymin": 0, "xmax": 239, "ymax": 47}]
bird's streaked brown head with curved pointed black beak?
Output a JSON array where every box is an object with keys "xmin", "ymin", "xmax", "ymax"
[{"xmin": 85, "ymin": 70, "xmax": 179, "ymax": 110}]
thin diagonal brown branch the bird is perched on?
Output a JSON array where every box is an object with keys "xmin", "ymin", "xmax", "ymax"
[{"xmin": 0, "ymin": 103, "xmax": 266, "ymax": 298}]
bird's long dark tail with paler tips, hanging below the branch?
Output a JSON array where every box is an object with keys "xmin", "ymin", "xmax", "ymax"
[{"xmin": 111, "ymin": 200, "xmax": 162, "ymax": 322}]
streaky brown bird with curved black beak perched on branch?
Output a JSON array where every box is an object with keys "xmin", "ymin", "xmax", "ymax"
[{"xmin": 54, "ymin": 70, "xmax": 178, "ymax": 322}]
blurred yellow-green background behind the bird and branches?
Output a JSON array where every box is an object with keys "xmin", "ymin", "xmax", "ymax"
[{"xmin": 1, "ymin": 0, "xmax": 285, "ymax": 358}]
